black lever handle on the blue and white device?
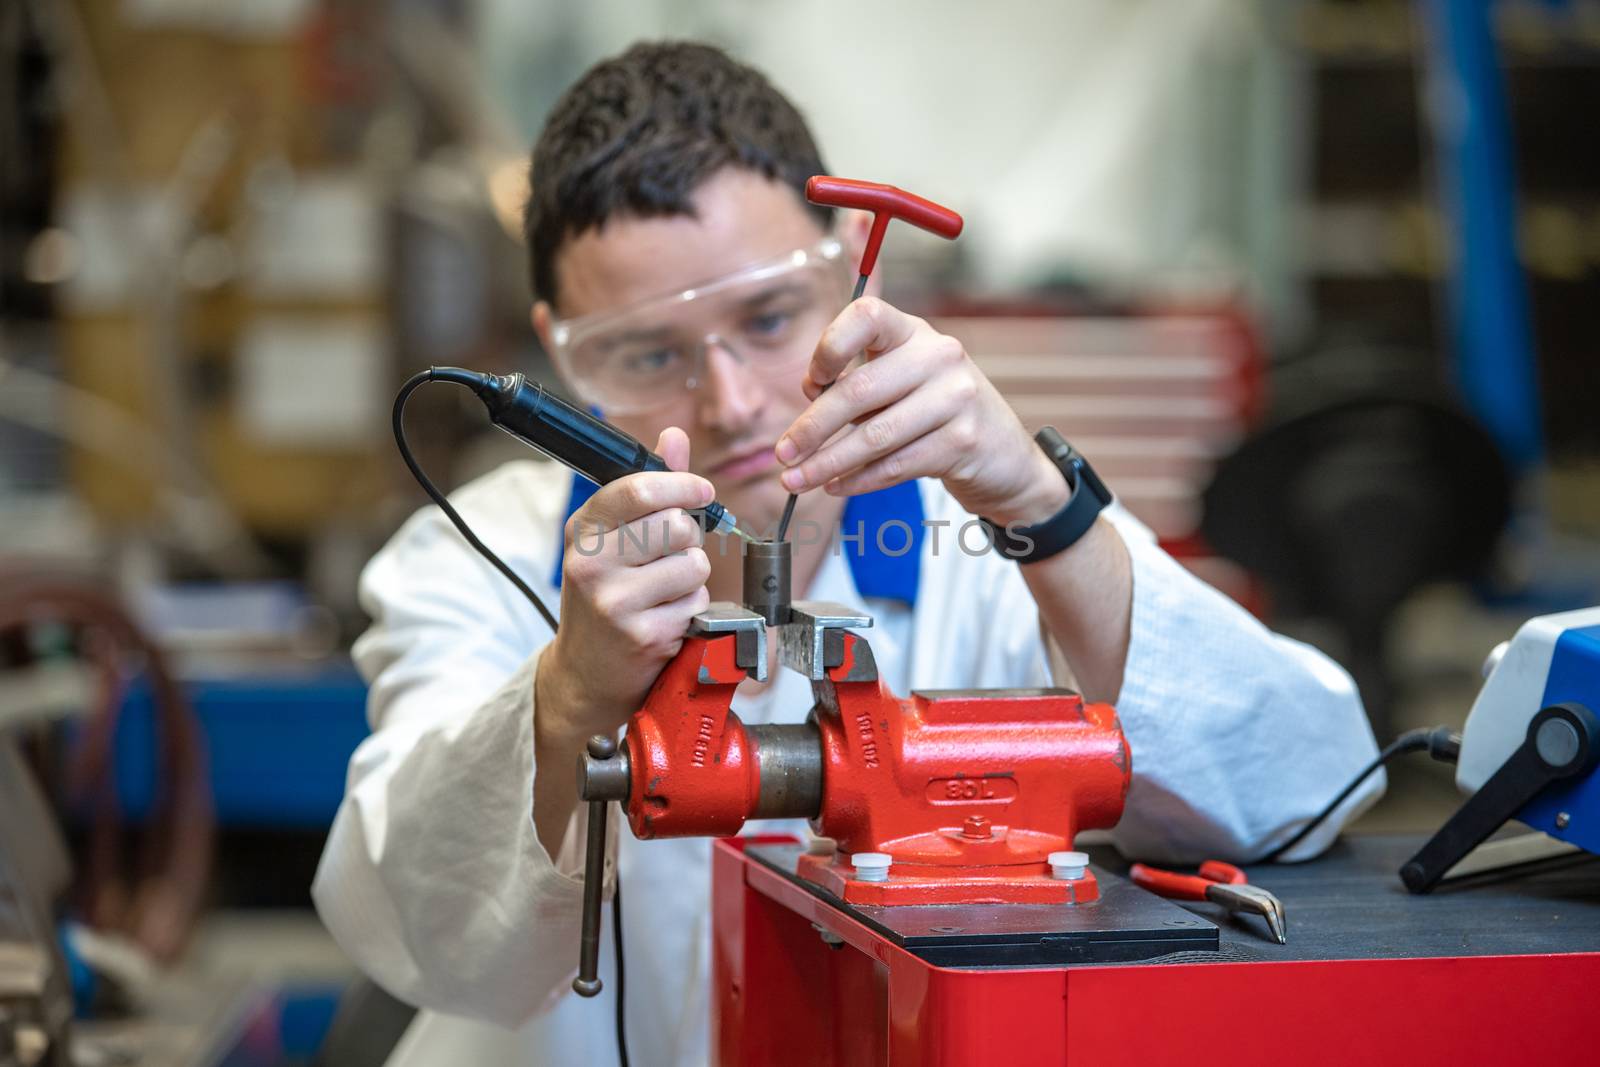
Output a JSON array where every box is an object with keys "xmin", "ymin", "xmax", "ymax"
[{"xmin": 1400, "ymin": 704, "xmax": 1600, "ymax": 893}]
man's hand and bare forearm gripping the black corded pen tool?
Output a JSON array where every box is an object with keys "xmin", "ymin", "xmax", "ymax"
[{"xmin": 534, "ymin": 427, "xmax": 715, "ymax": 854}]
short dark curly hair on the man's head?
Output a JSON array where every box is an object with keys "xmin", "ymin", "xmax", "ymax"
[{"xmin": 523, "ymin": 42, "xmax": 834, "ymax": 302}]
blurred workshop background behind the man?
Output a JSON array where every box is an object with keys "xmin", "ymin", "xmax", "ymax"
[{"xmin": 0, "ymin": 0, "xmax": 1600, "ymax": 1064}]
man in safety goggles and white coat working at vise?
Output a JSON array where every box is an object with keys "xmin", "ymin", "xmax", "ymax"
[{"xmin": 315, "ymin": 45, "xmax": 1381, "ymax": 1064}]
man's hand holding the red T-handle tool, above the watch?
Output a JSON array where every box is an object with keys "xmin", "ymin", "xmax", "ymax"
[{"xmin": 776, "ymin": 296, "xmax": 1067, "ymax": 525}]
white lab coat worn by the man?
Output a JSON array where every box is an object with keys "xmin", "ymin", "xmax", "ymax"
[{"xmin": 312, "ymin": 461, "xmax": 1382, "ymax": 1067}]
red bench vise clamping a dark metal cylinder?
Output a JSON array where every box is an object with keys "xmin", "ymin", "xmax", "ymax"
[{"xmin": 574, "ymin": 542, "xmax": 1131, "ymax": 995}]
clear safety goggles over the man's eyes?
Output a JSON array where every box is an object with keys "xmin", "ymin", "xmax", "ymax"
[{"xmin": 550, "ymin": 238, "xmax": 850, "ymax": 414}]
